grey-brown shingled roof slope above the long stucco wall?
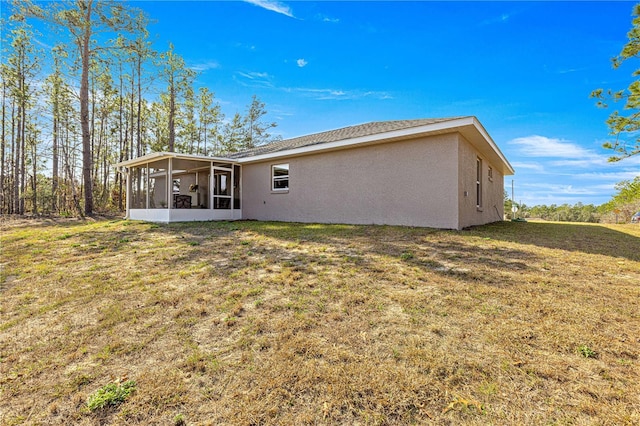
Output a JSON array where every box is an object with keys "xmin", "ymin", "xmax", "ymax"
[{"xmin": 223, "ymin": 117, "xmax": 463, "ymax": 159}]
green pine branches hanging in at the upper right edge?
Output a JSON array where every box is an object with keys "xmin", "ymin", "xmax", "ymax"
[{"xmin": 591, "ymin": 4, "xmax": 640, "ymax": 162}]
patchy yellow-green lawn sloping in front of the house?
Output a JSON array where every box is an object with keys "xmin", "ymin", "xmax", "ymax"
[{"xmin": 0, "ymin": 219, "xmax": 640, "ymax": 425}]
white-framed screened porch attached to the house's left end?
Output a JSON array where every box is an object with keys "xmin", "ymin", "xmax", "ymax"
[{"xmin": 115, "ymin": 152, "xmax": 242, "ymax": 223}]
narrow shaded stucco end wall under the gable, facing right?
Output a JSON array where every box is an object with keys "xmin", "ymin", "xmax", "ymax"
[{"xmin": 458, "ymin": 136, "xmax": 504, "ymax": 228}]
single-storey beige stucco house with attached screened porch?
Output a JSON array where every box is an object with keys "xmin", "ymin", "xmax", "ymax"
[{"xmin": 116, "ymin": 117, "xmax": 514, "ymax": 229}]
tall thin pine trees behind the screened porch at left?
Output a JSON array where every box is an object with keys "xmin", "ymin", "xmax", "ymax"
[{"xmin": 0, "ymin": 0, "xmax": 276, "ymax": 215}]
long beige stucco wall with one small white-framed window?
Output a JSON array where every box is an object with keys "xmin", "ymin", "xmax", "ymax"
[{"xmin": 242, "ymin": 134, "xmax": 460, "ymax": 229}]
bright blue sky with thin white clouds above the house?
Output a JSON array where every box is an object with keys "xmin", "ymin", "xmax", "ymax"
[{"xmin": 21, "ymin": 0, "xmax": 640, "ymax": 206}]
